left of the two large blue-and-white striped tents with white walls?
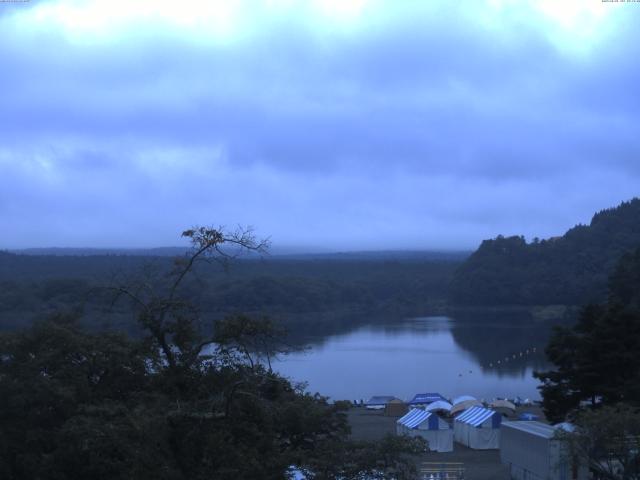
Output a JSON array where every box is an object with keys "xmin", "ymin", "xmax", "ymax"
[{"xmin": 396, "ymin": 408, "xmax": 453, "ymax": 452}]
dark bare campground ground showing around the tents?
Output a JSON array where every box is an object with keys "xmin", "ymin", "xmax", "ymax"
[{"xmin": 347, "ymin": 407, "xmax": 543, "ymax": 480}]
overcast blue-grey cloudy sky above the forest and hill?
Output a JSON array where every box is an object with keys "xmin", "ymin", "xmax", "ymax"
[{"xmin": 0, "ymin": 0, "xmax": 640, "ymax": 250}]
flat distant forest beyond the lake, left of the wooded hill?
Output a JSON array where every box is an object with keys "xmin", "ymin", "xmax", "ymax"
[{"xmin": 0, "ymin": 248, "xmax": 467, "ymax": 333}]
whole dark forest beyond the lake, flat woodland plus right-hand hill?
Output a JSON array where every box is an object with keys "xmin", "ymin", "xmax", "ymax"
[{"xmin": 5, "ymin": 199, "xmax": 640, "ymax": 326}]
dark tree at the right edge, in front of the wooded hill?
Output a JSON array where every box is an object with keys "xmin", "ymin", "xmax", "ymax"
[{"xmin": 536, "ymin": 249, "xmax": 640, "ymax": 421}]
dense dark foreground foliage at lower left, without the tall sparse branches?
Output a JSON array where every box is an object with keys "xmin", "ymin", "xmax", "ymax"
[{"xmin": 0, "ymin": 320, "xmax": 424, "ymax": 480}]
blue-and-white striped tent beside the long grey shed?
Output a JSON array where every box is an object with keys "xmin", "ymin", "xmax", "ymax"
[{"xmin": 453, "ymin": 406, "xmax": 502, "ymax": 450}]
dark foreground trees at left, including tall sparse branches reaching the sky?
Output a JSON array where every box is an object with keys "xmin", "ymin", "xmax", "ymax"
[{"xmin": 0, "ymin": 228, "xmax": 415, "ymax": 480}]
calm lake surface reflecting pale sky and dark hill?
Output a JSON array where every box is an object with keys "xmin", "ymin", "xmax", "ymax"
[{"xmin": 276, "ymin": 316, "xmax": 550, "ymax": 400}]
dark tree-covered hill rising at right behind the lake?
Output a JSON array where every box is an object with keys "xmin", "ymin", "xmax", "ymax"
[{"xmin": 450, "ymin": 198, "xmax": 640, "ymax": 305}]
